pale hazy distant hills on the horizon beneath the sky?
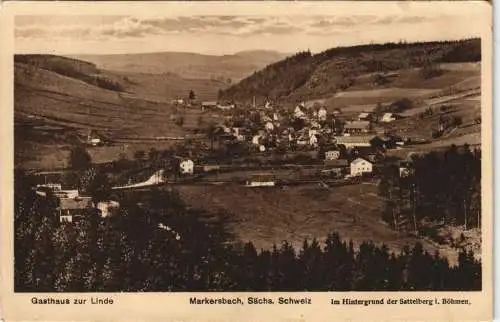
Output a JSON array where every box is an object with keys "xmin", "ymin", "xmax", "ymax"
[{"xmin": 74, "ymin": 50, "xmax": 285, "ymax": 83}]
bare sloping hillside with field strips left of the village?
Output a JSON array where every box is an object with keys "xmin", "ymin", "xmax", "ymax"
[{"xmin": 14, "ymin": 55, "xmax": 223, "ymax": 167}]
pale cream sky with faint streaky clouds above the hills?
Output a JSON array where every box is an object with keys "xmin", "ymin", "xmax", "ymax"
[{"xmin": 15, "ymin": 4, "xmax": 485, "ymax": 55}]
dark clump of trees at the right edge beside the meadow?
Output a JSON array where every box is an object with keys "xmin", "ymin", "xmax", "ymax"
[{"xmin": 379, "ymin": 144, "xmax": 481, "ymax": 231}]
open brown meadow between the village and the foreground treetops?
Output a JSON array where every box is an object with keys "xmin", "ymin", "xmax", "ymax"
[{"xmin": 177, "ymin": 184, "xmax": 464, "ymax": 262}]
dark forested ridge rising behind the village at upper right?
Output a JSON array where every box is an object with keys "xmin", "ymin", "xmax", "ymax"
[{"xmin": 219, "ymin": 38, "xmax": 481, "ymax": 102}]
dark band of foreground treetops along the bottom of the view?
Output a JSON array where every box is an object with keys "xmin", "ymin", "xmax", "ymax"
[{"xmin": 14, "ymin": 173, "xmax": 481, "ymax": 292}]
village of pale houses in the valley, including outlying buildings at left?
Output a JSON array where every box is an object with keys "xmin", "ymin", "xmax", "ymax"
[{"xmin": 34, "ymin": 95, "xmax": 422, "ymax": 226}]
